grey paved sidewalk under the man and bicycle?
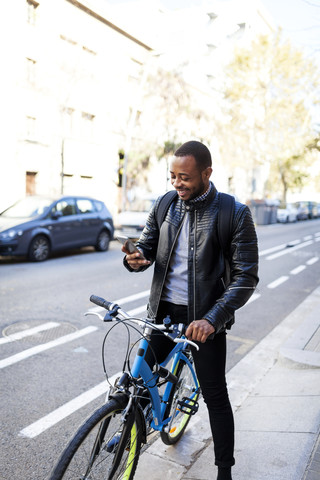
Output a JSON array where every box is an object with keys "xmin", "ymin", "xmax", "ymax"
[{"xmin": 135, "ymin": 287, "xmax": 320, "ymax": 480}]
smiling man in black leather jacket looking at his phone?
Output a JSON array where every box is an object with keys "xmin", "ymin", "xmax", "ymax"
[{"xmin": 122, "ymin": 141, "xmax": 258, "ymax": 480}]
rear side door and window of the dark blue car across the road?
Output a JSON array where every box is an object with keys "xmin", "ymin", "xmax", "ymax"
[{"xmin": 76, "ymin": 198, "xmax": 103, "ymax": 245}]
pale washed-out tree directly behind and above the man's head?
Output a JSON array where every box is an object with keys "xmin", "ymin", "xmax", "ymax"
[{"xmin": 124, "ymin": 68, "xmax": 216, "ymax": 193}]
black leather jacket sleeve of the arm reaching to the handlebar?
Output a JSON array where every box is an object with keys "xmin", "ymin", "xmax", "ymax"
[{"xmin": 204, "ymin": 205, "xmax": 259, "ymax": 333}]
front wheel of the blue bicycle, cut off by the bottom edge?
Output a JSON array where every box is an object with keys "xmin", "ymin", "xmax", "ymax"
[{"xmin": 49, "ymin": 396, "xmax": 143, "ymax": 480}]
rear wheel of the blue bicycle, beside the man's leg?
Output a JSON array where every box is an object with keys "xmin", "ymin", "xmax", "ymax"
[{"xmin": 160, "ymin": 356, "xmax": 200, "ymax": 445}]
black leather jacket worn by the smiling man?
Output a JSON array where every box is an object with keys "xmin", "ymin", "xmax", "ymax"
[{"xmin": 124, "ymin": 187, "xmax": 259, "ymax": 333}]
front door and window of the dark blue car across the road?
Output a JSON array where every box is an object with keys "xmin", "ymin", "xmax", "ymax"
[{"xmin": 48, "ymin": 197, "xmax": 81, "ymax": 249}]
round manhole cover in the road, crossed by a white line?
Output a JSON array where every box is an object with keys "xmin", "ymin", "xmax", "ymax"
[{"xmin": 2, "ymin": 320, "xmax": 78, "ymax": 345}]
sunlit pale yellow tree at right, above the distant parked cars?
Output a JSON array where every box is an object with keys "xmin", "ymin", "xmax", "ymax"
[{"xmin": 221, "ymin": 31, "xmax": 320, "ymax": 200}]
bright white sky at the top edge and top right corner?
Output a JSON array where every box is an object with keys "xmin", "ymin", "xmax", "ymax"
[{"xmin": 107, "ymin": 0, "xmax": 320, "ymax": 65}]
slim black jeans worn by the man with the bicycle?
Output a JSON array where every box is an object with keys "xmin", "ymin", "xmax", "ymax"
[{"xmin": 147, "ymin": 302, "xmax": 235, "ymax": 467}]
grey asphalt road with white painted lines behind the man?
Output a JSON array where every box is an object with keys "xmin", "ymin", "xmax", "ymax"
[{"xmin": 0, "ymin": 220, "xmax": 320, "ymax": 480}]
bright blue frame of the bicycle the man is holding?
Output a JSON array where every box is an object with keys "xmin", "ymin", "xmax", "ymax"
[{"xmin": 131, "ymin": 330, "xmax": 199, "ymax": 431}]
